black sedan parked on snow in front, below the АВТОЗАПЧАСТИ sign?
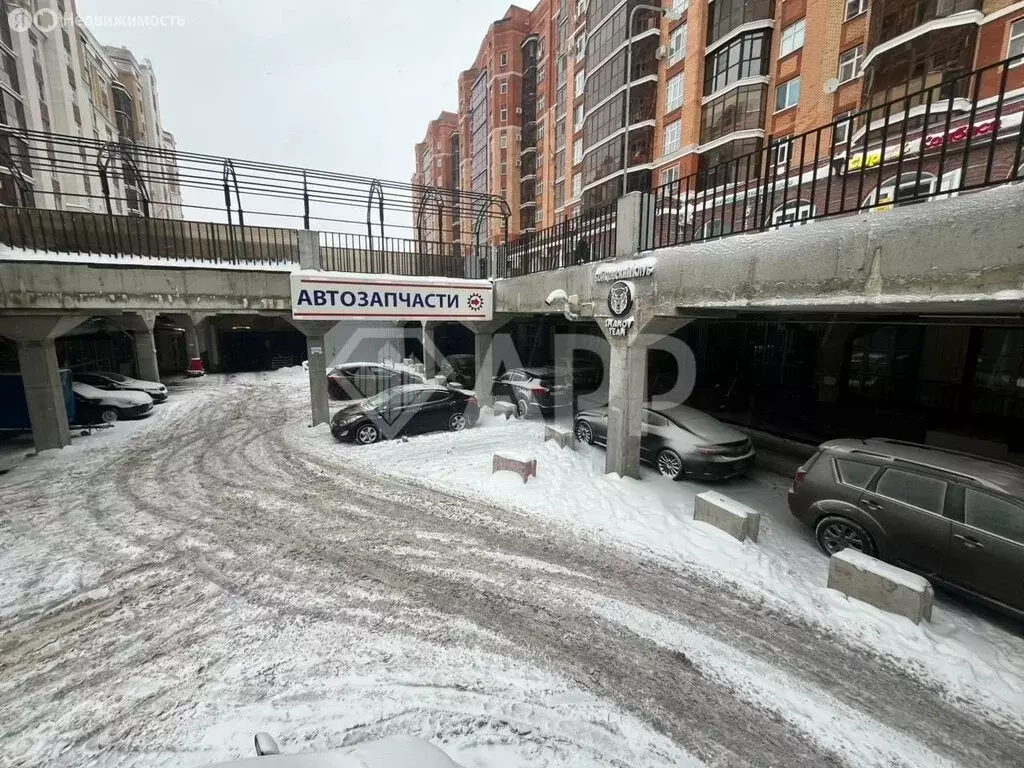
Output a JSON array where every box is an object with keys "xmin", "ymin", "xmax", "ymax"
[{"xmin": 331, "ymin": 384, "xmax": 480, "ymax": 445}]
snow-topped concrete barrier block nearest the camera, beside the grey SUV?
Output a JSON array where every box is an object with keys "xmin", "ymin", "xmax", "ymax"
[{"xmin": 826, "ymin": 549, "xmax": 935, "ymax": 624}]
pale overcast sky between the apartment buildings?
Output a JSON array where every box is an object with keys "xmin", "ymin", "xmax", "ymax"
[{"xmin": 77, "ymin": 0, "xmax": 537, "ymax": 228}]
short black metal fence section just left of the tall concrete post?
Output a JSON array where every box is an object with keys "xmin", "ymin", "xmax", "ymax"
[{"xmin": 494, "ymin": 203, "xmax": 618, "ymax": 278}]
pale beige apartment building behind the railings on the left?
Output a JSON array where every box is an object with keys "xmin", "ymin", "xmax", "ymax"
[{"xmin": 0, "ymin": 0, "xmax": 182, "ymax": 218}]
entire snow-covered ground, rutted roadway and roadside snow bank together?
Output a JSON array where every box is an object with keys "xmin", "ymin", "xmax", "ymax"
[{"xmin": 0, "ymin": 368, "xmax": 1024, "ymax": 768}]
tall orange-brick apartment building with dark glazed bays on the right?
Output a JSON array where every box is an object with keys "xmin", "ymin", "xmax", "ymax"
[{"xmin": 414, "ymin": 0, "xmax": 1024, "ymax": 246}]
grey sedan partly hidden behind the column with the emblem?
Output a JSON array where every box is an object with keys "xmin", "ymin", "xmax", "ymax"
[{"xmin": 573, "ymin": 406, "xmax": 754, "ymax": 480}]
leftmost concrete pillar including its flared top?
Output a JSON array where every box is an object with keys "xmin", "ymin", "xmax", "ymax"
[{"xmin": 0, "ymin": 315, "xmax": 88, "ymax": 451}]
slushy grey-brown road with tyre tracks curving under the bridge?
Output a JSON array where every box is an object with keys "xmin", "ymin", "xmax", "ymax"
[{"xmin": 0, "ymin": 377, "xmax": 1024, "ymax": 768}]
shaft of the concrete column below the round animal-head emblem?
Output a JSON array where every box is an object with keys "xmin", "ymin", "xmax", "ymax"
[{"xmin": 604, "ymin": 339, "xmax": 647, "ymax": 477}]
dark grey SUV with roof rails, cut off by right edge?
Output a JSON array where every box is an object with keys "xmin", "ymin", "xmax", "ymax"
[{"xmin": 790, "ymin": 439, "xmax": 1024, "ymax": 618}]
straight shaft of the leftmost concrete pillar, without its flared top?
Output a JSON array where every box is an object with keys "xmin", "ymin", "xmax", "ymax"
[{"xmin": 16, "ymin": 339, "xmax": 71, "ymax": 451}]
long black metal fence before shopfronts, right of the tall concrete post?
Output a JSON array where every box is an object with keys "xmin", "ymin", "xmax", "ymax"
[{"xmin": 641, "ymin": 54, "xmax": 1024, "ymax": 250}]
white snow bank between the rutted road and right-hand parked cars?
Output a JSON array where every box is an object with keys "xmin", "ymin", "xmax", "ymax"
[{"xmin": 284, "ymin": 382, "xmax": 1024, "ymax": 717}]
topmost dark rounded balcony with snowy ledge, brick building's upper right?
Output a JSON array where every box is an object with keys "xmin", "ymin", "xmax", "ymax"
[{"xmin": 863, "ymin": 0, "xmax": 984, "ymax": 70}]
